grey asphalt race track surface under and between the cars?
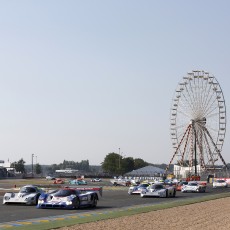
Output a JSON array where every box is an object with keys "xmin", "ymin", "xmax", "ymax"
[{"xmin": 0, "ymin": 186, "xmax": 230, "ymax": 223}]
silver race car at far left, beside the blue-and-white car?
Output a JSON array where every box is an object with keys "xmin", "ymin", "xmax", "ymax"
[{"xmin": 3, "ymin": 185, "xmax": 45, "ymax": 205}]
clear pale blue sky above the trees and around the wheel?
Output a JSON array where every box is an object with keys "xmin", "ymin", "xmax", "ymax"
[{"xmin": 0, "ymin": 0, "xmax": 230, "ymax": 165}]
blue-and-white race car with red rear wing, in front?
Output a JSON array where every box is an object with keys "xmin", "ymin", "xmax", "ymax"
[{"xmin": 37, "ymin": 187, "xmax": 102, "ymax": 209}]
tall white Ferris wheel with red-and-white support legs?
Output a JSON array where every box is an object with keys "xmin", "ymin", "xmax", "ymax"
[{"xmin": 166, "ymin": 71, "xmax": 227, "ymax": 170}]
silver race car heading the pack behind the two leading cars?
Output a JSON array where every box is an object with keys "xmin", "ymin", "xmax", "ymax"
[{"xmin": 140, "ymin": 183, "xmax": 176, "ymax": 197}]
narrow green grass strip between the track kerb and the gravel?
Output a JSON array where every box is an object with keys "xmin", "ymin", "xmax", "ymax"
[{"xmin": 4, "ymin": 193, "xmax": 230, "ymax": 230}]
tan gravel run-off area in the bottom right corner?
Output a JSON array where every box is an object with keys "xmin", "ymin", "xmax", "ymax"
[{"xmin": 56, "ymin": 197, "xmax": 230, "ymax": 230}]
